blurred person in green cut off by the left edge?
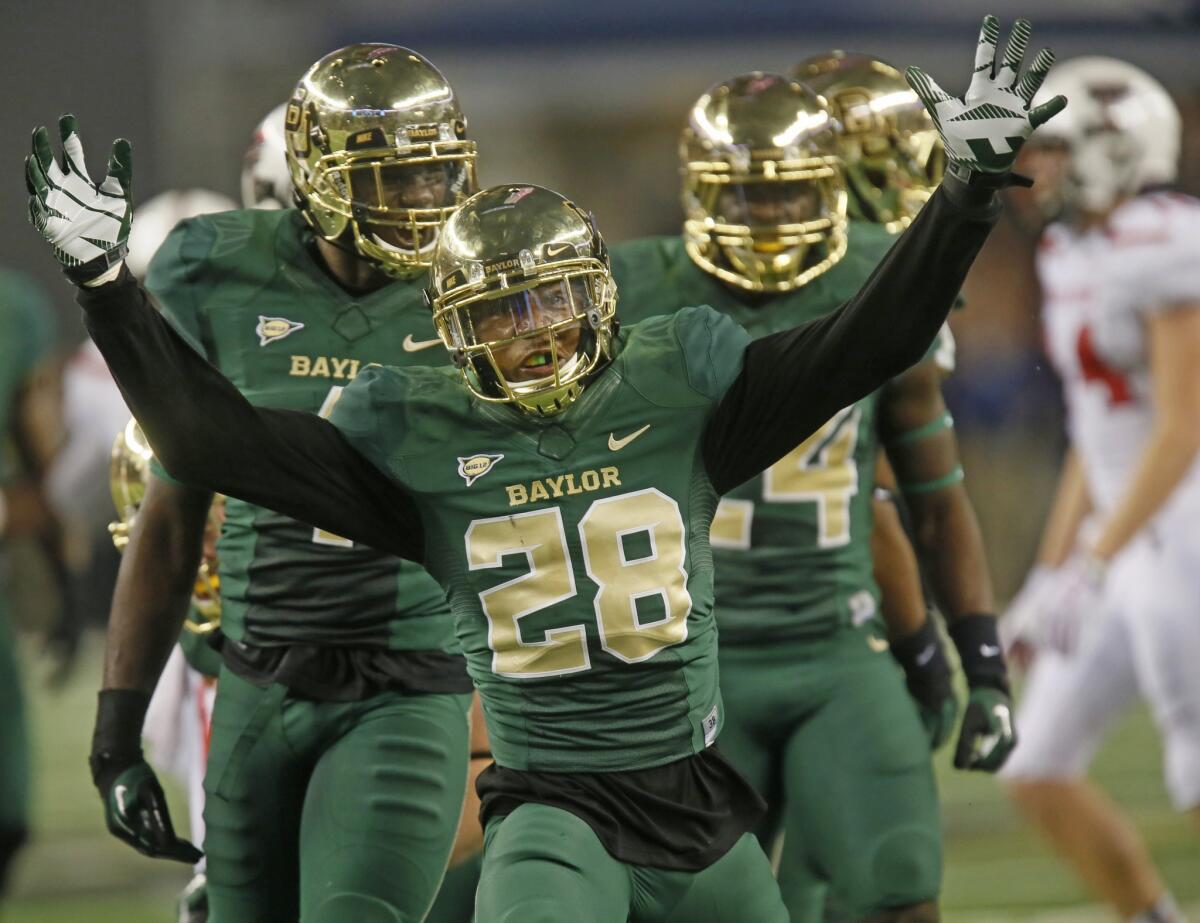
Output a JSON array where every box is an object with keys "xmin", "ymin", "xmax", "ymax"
[{"xmin": 0, "ymin": 270, "xmax": 54, "ymax": 897}]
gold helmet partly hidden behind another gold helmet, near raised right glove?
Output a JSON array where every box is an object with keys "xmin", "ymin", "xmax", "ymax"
[{"xmin": 792, "ymin": 52, "xmax": 946, "ymax": 234}]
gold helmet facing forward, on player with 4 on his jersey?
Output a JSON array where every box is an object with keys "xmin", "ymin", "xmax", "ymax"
[{"xmin": 679, "ymin": 72, "xmax": 846, "ymax": 292}]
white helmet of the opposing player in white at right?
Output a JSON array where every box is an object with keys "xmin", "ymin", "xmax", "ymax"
[{"xmin": 1034, "ymin": 56, "xmax": 1182, "ymax": 212}]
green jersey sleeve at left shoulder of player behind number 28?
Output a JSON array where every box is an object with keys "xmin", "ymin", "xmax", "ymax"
[{"xmin": 145, "ymin": 218, "xmax": 216, "ymax": 359}]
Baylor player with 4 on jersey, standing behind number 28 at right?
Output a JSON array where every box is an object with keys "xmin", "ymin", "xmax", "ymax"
[{"xmin": 613, "ymin": 48, "xmax": 1003, "ymax": 921}]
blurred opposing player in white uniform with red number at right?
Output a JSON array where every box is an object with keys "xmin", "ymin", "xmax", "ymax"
[{"xmin": 1004, "ymin": 58, "xmax": 1200, "ymax": 923}]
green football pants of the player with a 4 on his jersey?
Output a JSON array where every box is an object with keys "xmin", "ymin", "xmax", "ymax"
[{"xmin": 720, "ymin": 623, "xmax": 942, "ymax": 923}]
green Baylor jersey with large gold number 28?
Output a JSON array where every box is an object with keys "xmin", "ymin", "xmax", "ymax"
[{"xmin": 332, "ymin": 308, "xmax": 749, "ymax": 772}]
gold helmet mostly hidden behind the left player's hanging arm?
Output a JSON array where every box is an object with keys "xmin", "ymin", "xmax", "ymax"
[{"xmin": 108, "ymin": 420, "xmax": 224, "ymax": 635}]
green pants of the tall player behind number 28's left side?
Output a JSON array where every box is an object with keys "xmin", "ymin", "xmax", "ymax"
[{"xmin": 204, "ymin": 669, "xmax": 470, "ymax": 923}]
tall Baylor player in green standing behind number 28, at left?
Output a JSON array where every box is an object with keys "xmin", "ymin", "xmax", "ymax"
[{"xmin": 75, "ymin": 44, "xmax": 475, "ymax": 921}]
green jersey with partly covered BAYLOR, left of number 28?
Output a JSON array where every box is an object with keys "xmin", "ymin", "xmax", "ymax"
[{"xmin": 146, "ymin": 209, "xmax": 457, "ymax": 651}]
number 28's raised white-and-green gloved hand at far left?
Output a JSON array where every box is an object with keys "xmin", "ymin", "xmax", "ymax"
[{"xmin": 25, "ymin": 115, "xmax": 133, "ymax": 284}]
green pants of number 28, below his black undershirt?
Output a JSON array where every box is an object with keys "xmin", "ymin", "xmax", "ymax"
[{"xmin": 475, "ymin": 804, "xmax": 787, "ymax": 923}]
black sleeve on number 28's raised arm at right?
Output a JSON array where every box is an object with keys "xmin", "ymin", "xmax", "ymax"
[{"xmin": 703, "ymin": 176, "xmax": 1001, "ymax": 493}]
